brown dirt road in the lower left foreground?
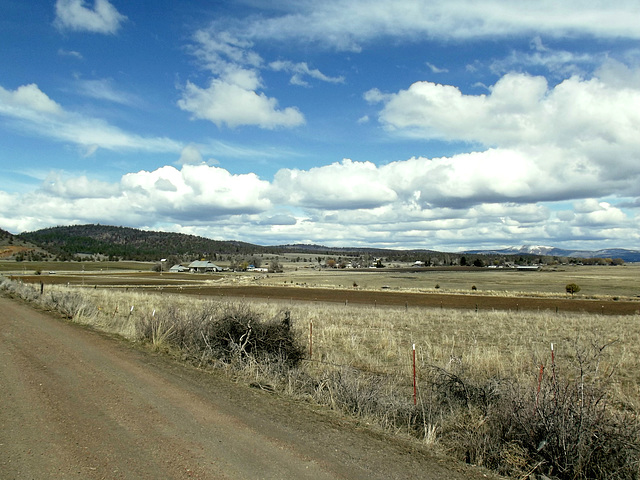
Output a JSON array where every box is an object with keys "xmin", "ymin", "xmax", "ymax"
[{"xmin": 0, "ymin": 297, "xmax": 500, "ymax": 480}]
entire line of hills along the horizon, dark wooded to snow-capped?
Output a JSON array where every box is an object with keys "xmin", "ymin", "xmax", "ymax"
[{"xmin": 0, "ymin": 225, "xmax": 640, "ymax": 265}]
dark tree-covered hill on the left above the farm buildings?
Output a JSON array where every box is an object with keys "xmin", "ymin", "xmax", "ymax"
[{"xmin": 16, "ymin": 225, "xmax": 269, "ymax": 261}]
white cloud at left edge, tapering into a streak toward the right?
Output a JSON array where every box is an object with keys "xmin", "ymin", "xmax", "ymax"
[{"xmin": 0, "ymin": 84, "xmax": 182, "ymax": 154}]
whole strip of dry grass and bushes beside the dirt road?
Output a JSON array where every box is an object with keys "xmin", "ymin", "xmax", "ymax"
[{"xmin": 0, "ymin": 280, "xmax": 640, "ymax": 479}]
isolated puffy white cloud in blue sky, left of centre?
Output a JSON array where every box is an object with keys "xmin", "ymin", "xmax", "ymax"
[{"xmin": 178, "ymin": 78, "xmax": 305, "ymax": 129}]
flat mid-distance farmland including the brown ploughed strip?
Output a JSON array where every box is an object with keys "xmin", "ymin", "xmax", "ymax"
[{"xmin": 4, "ymin": 262, "xmax": 640, "ymax": 315}]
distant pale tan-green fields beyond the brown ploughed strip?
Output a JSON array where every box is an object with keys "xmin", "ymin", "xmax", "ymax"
[{"xmin": 0, "ymin": 261, "xmax": 640, "ymax": 299}]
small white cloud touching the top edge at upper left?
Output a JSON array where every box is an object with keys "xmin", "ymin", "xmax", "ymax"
[{"xmin": 54, "ymin": 0, "xmax": 127, "ymax": 34}]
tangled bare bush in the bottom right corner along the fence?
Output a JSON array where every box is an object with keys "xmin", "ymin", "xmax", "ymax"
[{"xmin": 430, "ymin": 343, "xmax": 640, "ymax": 479}]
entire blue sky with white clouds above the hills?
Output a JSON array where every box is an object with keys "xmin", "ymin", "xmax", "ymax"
[{"xmin": 0, "ymin": 0, "xmax": 640, "ymax": 252}]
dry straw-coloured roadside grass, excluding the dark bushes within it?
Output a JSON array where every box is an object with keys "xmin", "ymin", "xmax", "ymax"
[{"xmin": 2, "ymin": 273, "xmax": 640, "ymax": 478}]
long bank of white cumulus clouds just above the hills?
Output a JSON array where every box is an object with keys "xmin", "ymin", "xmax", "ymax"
[{"xmin": 0, "ymin": 154, "xmax": 640, "ymax": 250}]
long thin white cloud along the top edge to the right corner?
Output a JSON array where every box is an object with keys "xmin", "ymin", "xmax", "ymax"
[{"xmin": 218, "ymin": 0, "xmax": 640, "ymax": 51}]
